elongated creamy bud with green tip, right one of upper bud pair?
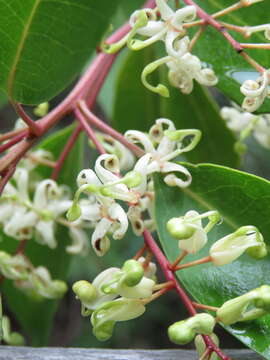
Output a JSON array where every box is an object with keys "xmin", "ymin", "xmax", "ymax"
[{"xmin": 209, "ymin": 226, "xmax": 267, "ymax": 266}]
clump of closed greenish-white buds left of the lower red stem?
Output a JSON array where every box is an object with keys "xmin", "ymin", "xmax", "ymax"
[{"xmin": 73, "ymin": 258, "xmax": 156, "ymax": 341}]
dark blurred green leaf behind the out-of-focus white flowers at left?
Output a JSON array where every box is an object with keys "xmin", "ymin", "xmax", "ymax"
[{"xmin": 1, "ymin": 127, "xmax": 83, "ymax": 346}]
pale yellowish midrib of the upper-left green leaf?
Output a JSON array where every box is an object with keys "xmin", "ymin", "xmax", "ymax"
[{"xmin": 7, "ymin": 0, "xmax": 41, "ymax": 98}]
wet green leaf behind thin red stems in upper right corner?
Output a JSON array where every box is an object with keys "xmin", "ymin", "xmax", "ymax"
[{"xmin": 193, "ymin": 0, "xmax": 270, "ymax": 113}]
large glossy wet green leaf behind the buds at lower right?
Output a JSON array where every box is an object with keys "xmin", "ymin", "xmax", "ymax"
[{"xmin": 155, "ymin": 164, "xmax": 270, "ymax": 359}]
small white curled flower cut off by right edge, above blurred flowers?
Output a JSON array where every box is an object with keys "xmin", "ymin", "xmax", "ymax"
[{"xmin": 240, "ymin": 70, "xmax": 270, "ymax": 112}]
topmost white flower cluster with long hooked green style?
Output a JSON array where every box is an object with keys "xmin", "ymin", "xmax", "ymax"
[{"xmin": 103, "ymin": 0, "xmax": 217, "ymax": 97}]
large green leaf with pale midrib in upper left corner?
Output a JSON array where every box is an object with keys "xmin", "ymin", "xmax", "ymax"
[{"xmin": 0, "ymin": 0, "xmax": 118, "ymax": 104}]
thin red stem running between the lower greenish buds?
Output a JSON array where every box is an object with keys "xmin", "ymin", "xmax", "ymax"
[{"xmin": 143, "ymin": 230, "xmax": 231, "ymax": 360}]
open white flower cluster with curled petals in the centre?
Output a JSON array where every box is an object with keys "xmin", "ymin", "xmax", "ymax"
[{"xmin": 67, "ymin": 119, "xmax": 201, "ymax": 256}]
